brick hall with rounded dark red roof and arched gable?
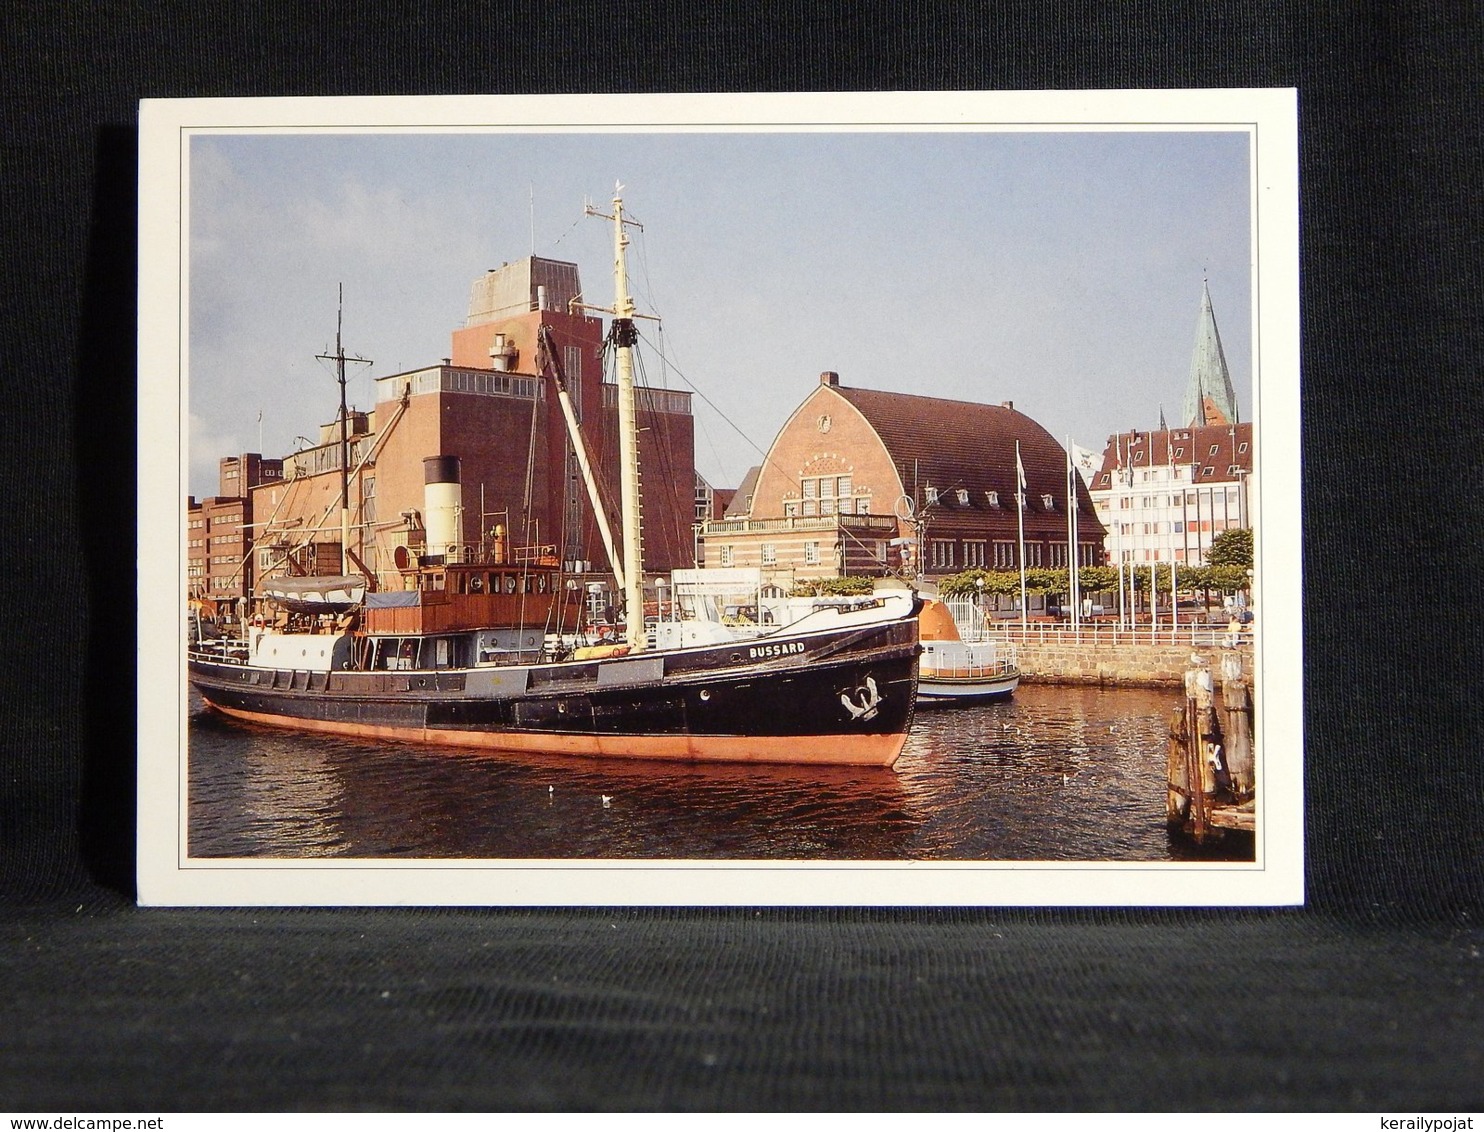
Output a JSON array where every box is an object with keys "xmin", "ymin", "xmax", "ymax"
[{"xmin": 702, "ymin": 372, "xmax": 1104, "ymax": 589}]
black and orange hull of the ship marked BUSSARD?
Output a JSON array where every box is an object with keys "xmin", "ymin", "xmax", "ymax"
[{"xmin": 190, "ymin": 619, "xmax": 917, "ymax": 766}]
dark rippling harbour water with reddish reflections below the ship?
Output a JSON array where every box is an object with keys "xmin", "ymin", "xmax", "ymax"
[{"xmin": 188, "ymin": 685, "xmax": 1252, "ymax": 860}]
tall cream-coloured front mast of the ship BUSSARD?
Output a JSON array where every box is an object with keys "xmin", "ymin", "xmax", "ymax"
[{"xmin": 585, "ymin": 185, "xmax": 649, "ymax": 653}]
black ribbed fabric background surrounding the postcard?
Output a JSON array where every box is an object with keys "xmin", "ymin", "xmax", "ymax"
[{"xmin": 0, "ymin": 1, "xmax": 1484, "ymax": 1113}]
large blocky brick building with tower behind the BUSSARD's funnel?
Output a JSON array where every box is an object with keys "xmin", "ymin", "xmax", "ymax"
[{"xmin": 231, "ymin": 257, "xmax": 695, "ymax": 585}]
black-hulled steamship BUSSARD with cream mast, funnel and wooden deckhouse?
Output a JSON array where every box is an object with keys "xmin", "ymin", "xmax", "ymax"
[{"xmin": 188, "ymin": 196, "xmax": 920, "ymax": 767}]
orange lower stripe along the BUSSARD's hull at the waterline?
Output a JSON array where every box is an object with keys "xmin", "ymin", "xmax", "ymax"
[{"xmin": 208, "ymin": 700, "xmax": 907, "ymax": 767}]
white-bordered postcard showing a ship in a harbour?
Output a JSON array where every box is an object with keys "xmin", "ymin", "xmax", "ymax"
[{"xmin": 138, "ymin": 91, "xmax": 1303, "ymax": 905}]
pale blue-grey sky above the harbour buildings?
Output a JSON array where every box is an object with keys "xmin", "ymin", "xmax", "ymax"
[{"xmin": 187, "ymin": 129, "xmax": 1252, "ymax": 497}]
